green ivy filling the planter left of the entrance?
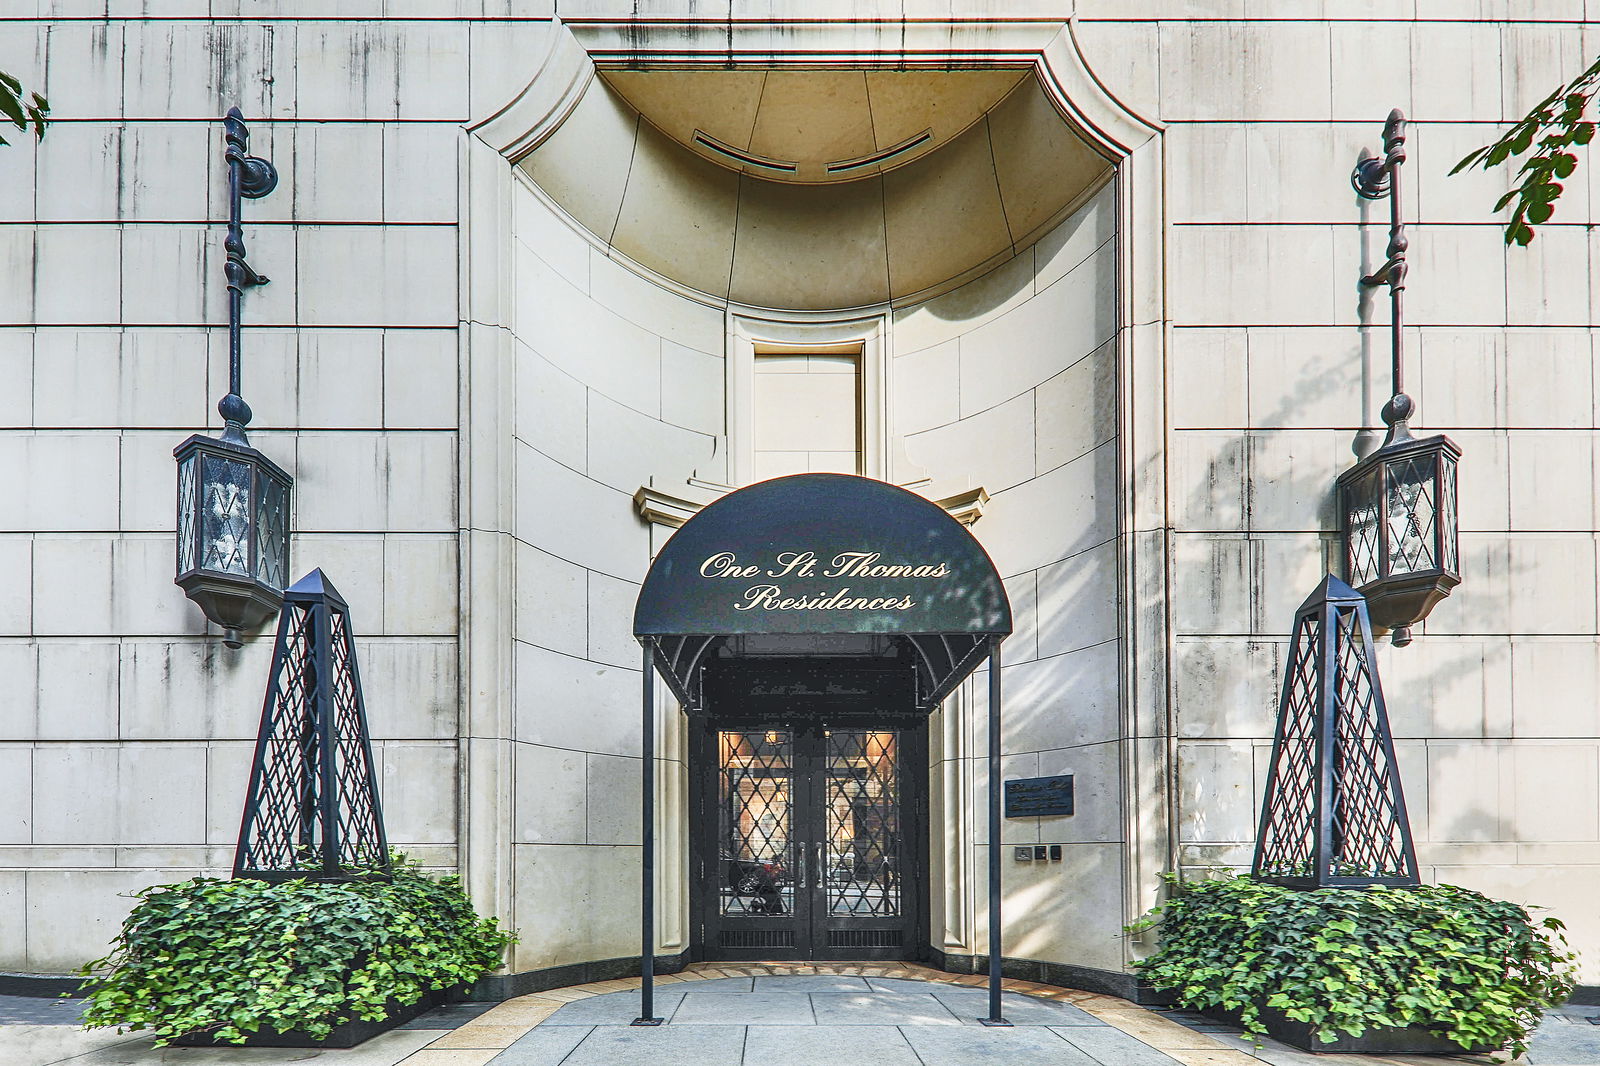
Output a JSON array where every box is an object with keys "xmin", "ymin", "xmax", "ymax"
[{"xmin": 82, "ymin": 863, "xmax": 514, "ymax": 1047}]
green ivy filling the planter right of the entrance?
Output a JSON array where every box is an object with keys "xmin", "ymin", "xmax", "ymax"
[{"xmin": 1130, "ymin": 877, "xmax": 1576, "ymax": 1055}]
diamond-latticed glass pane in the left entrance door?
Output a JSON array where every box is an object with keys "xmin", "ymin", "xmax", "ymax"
[{"xmin": 717, "ymin": 730, "xmax": 795, "ymax": 914}]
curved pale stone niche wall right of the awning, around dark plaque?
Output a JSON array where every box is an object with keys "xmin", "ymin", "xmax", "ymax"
[{"xmin": 891, "ymin": 186, "xmax": 1125, "ymax": 970}]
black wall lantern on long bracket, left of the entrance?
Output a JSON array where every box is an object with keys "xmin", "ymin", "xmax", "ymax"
[{"xmin": 173, "ymin": 107, "xmax": 294, "ymax": 648}]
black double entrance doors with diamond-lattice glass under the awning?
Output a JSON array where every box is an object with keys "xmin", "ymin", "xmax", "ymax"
[{"xmin": 691, "ymin": 717, "xmax": 926, "ymax": 960}]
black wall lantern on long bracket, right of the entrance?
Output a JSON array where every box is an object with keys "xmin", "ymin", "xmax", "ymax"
[{"xmin": 1338, "ymin": 109, "xmax": 1461, "ymax": 648}]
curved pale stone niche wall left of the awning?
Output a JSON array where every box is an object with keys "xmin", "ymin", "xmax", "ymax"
[{"xmin": 505, "ymin": 182, "xmax": 726, "ymax": 970}]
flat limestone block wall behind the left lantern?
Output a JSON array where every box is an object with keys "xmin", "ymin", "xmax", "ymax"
[{"xmin": 0, "ymin": 10, "xmax": 474, "ymax": 972}]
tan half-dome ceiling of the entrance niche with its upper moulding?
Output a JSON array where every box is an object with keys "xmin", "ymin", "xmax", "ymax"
[{"xmin": 475, "ymin": 22, "xmax": 1154, "ymax": 311}]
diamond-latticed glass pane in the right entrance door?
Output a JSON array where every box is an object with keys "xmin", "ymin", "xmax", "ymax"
[{"xmin": 824, "ymin": 728, "xmax": 901, "ymax": 917}]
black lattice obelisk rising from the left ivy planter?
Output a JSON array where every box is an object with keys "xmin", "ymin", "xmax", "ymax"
[{"xmin": 234, "ymin": 570, "xmax": 389, "ymax": 880}]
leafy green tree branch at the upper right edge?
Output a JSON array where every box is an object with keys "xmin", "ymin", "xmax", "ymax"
[{"xmin": 1450, "ymin": 59, "xmax": 1600, "ymax": 246}]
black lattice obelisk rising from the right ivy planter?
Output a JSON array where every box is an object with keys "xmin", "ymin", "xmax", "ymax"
[{"xmin": 1251, "ymin": 575, "xmax": 1418, "ymax": 888}]
